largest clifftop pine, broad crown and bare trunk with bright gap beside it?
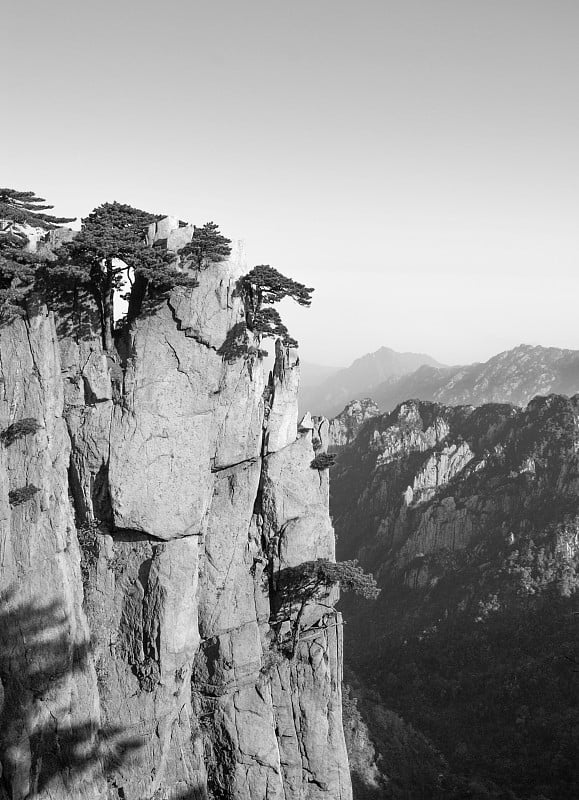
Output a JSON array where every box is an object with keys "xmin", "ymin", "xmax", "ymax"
[{"xmin": 54, "ymin": 202, "xmax": 197, "ymax": 351}]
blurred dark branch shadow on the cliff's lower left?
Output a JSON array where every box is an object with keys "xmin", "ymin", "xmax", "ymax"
[{"xmin": 0, "ymin": 588, "xmax": 142, "ymax": 800}]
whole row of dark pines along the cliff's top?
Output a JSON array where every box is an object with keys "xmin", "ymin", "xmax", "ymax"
[{"xmin": 0, "ymin": 188, "xmax": 313, "ymax": 354}]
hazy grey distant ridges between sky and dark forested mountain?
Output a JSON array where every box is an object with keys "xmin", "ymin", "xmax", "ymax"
[{"xmin": 302, "ymin": 344, "xmax": 579, "ymax": 417}]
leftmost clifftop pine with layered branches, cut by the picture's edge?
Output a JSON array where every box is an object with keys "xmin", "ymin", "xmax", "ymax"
[{"xmin": 0, "ymin": 188, "xmax": 74, "ymax": 322}]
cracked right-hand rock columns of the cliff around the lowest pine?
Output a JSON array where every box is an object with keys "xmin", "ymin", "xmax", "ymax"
[{"xmin": 193, "ymin": 344, "xmax": 351, "ymax": 800}]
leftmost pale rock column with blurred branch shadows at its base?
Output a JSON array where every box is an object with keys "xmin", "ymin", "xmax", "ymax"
[{"xmin": 0, "ymin": 309, "xmax": 105, "ymax": 800}]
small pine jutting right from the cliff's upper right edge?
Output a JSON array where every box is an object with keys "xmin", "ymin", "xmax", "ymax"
[{"xmin": 240, "ymin": 264, "xmax": 314, "ymax": 347}]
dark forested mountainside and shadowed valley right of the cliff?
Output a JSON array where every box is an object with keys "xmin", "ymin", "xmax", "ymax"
[{"xmin": 331, "ymin": 395, "xmax": 579, "ymax": 800}]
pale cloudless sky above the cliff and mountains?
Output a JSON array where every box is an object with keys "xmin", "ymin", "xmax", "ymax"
[{"xmin": 0, "ymin": 0, "xmax": 579, "ymax": 365}]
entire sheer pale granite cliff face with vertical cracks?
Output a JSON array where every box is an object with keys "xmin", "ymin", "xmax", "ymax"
[{"xmin": 0, "ymin": 226, "xmax": 351, "ymax": 800}]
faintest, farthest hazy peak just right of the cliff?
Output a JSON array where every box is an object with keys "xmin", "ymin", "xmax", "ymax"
[{"xmin": 300, "ymin": 347, "xmax": 444, "ymax": 417}]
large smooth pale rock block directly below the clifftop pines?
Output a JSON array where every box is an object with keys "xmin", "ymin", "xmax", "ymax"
[{"xmin": 109, "ymin": 250, "xmax": 264, "ymax": 539}]
